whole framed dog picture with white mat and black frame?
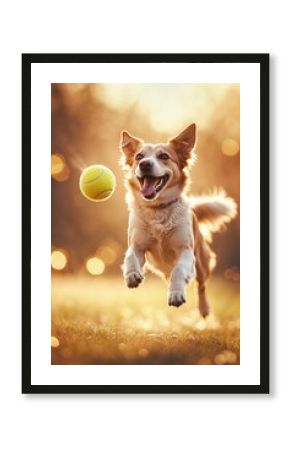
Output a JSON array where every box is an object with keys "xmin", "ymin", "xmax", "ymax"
[{"xmin": 22, "ymin": 54, "xmax": 269, "ymax": 394}]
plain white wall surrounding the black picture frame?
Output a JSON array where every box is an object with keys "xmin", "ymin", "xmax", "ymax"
[{"xmin": 0, "ymin": 0, "xmax": 290, "ymax": 450}]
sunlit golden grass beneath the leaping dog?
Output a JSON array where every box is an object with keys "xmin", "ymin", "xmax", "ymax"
[{"xmin": 52, "ymin": 275, "xmax": 240, "ymax": 364}]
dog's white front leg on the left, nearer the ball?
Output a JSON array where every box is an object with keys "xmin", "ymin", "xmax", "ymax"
[{"xmin": 124, "ymin": 245, "xmax": 145, "ymax": 288}]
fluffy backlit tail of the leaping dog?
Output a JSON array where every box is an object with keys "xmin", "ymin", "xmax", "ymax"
[{"xmin": 192, "ymin": 189, "xmax": 237, "ymax": 240}]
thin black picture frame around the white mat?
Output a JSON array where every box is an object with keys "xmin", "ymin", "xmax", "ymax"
[{"xmin": 22, "ymin": 53, "xmax": 270, "ymax": 394}]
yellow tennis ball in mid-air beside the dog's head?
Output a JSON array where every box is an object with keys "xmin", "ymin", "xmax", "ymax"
[{"xmin": 80, "ymin": 164, "xmax": 116, "ymax": 202}]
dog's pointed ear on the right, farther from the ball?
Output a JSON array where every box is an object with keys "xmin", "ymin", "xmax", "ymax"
[{"xmin": 169, "ymin": 123, "xmax": 196, "ymax": 167}]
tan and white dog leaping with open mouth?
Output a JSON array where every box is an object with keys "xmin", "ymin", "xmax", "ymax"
[{"xmin": 120, "ymin": 124, "xmax": 237, "ymax": 317}]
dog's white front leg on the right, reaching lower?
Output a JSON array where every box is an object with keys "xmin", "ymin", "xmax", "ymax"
[{"xmin": 168, "ymin": 248, "xmax": 195, "ymax": 307}]
